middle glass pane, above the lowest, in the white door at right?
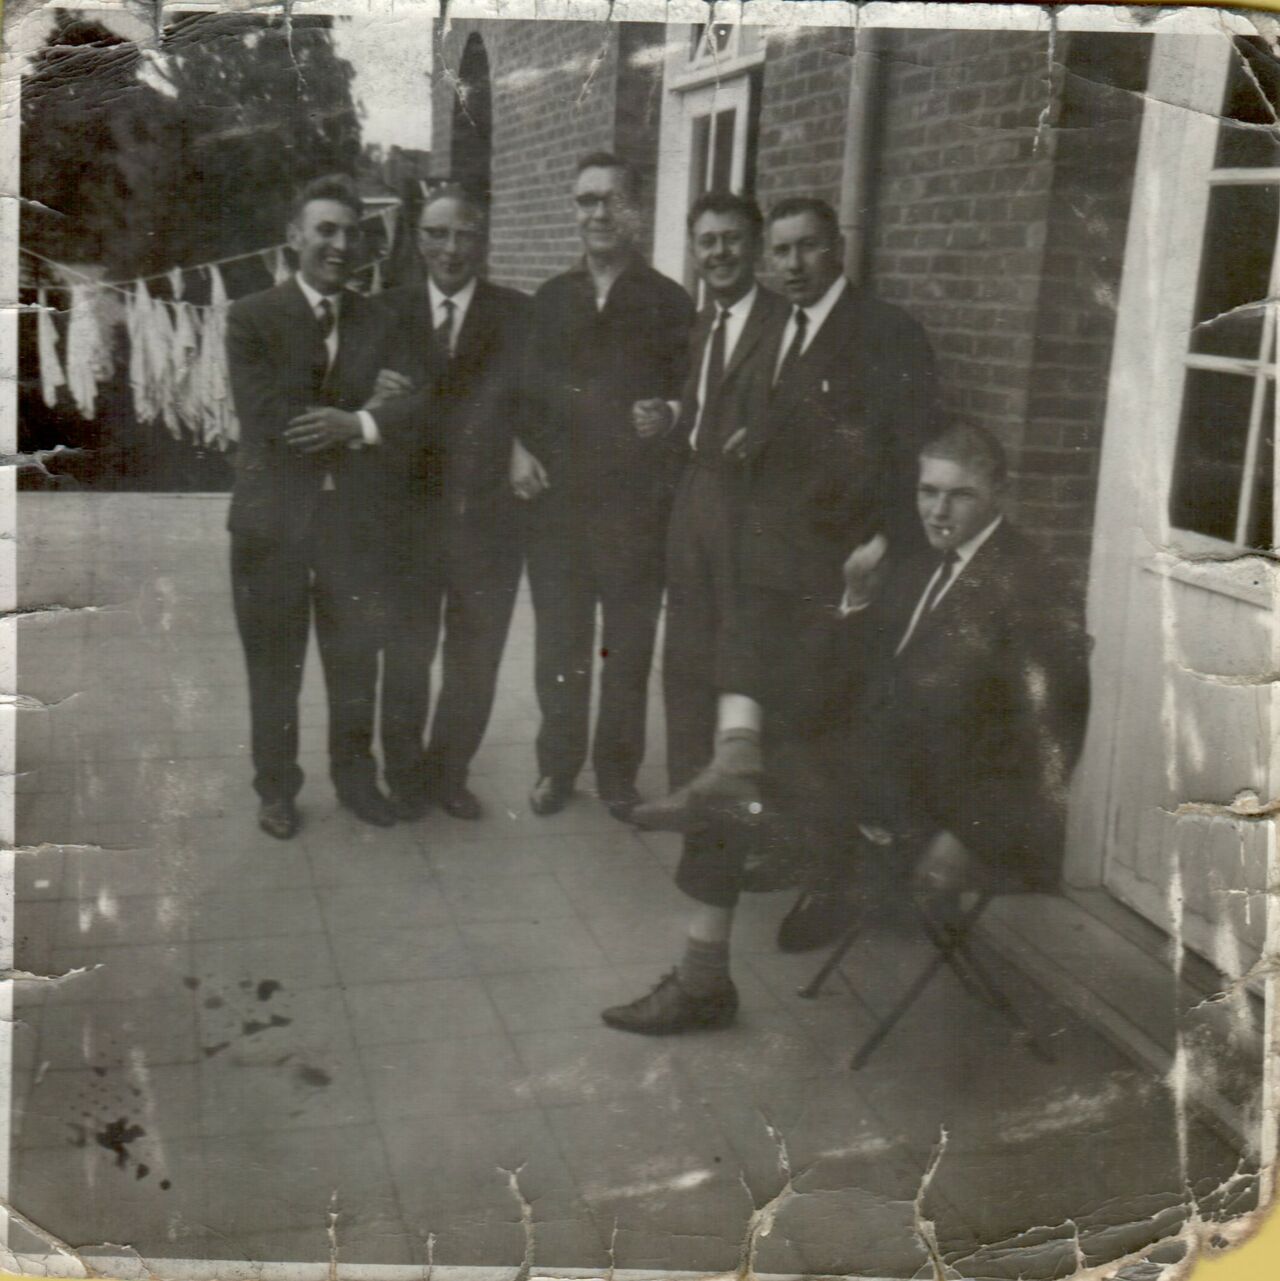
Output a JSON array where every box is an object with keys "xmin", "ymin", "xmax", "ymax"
[{"xmin": 1192, "ymin": 186, "xmax": 1280, "ymax": 360}]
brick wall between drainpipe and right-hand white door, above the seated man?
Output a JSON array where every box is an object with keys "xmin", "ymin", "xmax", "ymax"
[{"xmin": 870, "ymin": 32, "xmax": 1147, "ymax": 574}]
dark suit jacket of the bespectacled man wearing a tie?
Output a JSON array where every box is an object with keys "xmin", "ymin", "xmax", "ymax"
[{"xmin": 374, "ymin": 281, "xmax": 529, "ymax": 521}]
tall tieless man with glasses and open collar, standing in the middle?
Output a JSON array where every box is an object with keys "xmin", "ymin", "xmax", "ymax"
[{"xmin": 513, "ymin": 152, "xmax": 693, "ymax": 819}]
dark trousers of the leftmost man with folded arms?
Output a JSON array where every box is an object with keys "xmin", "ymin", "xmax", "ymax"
[{"xmin": 231, "ymin": 507, "xmax": 381, "ymax": 801}]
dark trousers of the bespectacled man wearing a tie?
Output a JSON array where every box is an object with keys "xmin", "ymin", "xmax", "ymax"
[{"xmin": 382, "ymin": 512, "xmax": 520, "ymax": 793}]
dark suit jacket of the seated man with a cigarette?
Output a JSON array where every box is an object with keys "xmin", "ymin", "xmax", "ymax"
[{"xmin": 849, "ymin": 520, "xmax": 1089, "ymax": 888}]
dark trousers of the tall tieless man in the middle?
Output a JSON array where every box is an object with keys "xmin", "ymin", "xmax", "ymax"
[{"xmin": 527, "ymin": 494, "xmax": 666, "ymax": 792}]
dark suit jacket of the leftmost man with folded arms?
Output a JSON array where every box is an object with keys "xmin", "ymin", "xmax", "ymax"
[{"xmin": 227, "ymin": 281, "xmax": 388, "ymax": 542}]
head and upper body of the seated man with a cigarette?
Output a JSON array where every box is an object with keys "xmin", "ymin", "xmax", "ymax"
[{"xmin": 843, "ymin": 427, "xmax": 1089, "ymax": 893}]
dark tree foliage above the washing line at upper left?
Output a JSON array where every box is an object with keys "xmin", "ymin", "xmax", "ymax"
[{"xmin": 22, "ymin": 13, "xmax": 360, "ymax": 275}]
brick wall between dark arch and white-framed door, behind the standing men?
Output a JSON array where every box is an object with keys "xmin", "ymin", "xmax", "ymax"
[{"xmin": 432, "ymin": 19, "xmax": 664, "ymax": 292}]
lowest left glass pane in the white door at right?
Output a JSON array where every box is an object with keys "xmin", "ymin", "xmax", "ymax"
[{"xmin": 1169, "ymin": 369, "xmax": 1256, "ymax": 543}]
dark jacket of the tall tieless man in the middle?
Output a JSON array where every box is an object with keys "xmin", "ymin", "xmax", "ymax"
[{"xmin": 521, "ymin": 256, "xmax": 693, "ymax": 517}]
